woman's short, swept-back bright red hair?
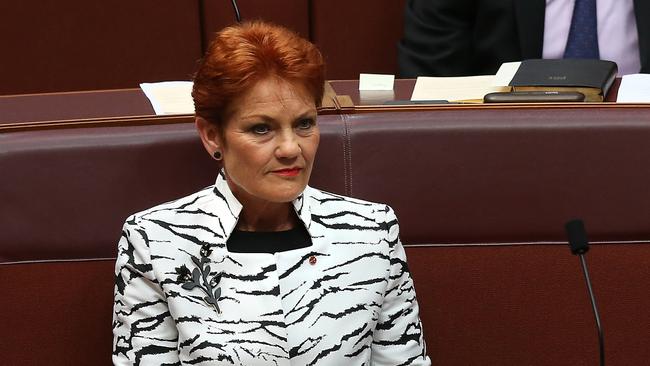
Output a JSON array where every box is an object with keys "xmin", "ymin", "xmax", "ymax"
[{"xmin": 192, "ymin": 21, "xmax": 325, "ymax": 124}]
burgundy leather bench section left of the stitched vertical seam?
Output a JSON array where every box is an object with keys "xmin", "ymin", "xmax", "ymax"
[{"xmin": 0, "ymin": 116, "xmax": 344, "ymax": 365}]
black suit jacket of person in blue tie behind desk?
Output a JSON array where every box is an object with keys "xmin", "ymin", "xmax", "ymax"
[{"xmin": 398, "ymin": 0, "xmax": 650, "ymax": 78}]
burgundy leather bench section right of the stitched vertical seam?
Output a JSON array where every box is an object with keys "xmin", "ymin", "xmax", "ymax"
[{"xmin": 346, "ymin": 107, "xmax": 650, "ymax": 365}]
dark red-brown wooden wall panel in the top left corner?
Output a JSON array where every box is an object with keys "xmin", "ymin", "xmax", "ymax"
[{"xmin": 0, "ymin": 0, "xmax": 201, "ymax": 94}]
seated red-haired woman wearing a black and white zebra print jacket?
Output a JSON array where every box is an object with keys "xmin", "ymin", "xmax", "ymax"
[{"xmin": 113, "ymin": 22, "xmax": 430, "ymax": 365}]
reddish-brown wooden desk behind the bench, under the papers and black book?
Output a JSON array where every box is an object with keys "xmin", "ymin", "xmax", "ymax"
[{"xmin": 0, "ymin": 79, "xmax": 650, "ymax": 133}]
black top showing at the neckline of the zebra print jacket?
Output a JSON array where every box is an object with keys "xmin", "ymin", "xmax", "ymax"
[{"xmin": 226, "ymin": 225, "xmax": 311, "ymax": 254}]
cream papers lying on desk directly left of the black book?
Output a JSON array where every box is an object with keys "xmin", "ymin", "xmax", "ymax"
[{"xmin": 411, "ymin": 75, "xmax": 510, "ymax": 103}]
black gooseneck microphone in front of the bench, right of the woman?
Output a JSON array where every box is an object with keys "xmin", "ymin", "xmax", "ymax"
[{"xmin": 564, "ymin": 219, "xmax": 605, "ymax": 366}]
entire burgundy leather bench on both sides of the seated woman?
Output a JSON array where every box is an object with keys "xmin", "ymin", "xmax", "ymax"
[{"xmin": 0, "ymin": 107, "xmax": 650, "ymax": 365}]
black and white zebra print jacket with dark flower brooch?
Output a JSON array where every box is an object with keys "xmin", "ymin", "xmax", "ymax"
[{"xmin": 113, "ymin": 173, "xmax": 431, "ymax": 366}]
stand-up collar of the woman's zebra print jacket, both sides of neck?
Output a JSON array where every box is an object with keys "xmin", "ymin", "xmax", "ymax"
[{"xmin": 214, "ymin": 170, "xmax": 312, "ymax": 237}]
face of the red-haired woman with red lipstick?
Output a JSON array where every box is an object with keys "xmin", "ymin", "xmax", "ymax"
[{"xmin": 199, "ymin": 78, "xmax": 320, "ymax": 206}]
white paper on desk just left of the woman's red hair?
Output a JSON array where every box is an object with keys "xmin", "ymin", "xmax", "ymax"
[{"xmin": 140, "ymin": 81, "xmax": 194, "ymax": 115}]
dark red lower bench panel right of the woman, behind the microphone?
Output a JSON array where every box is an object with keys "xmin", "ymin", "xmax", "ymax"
[{"xmin": 406, "ymin": 242, "xmax": 650, "ymax": 366}]
